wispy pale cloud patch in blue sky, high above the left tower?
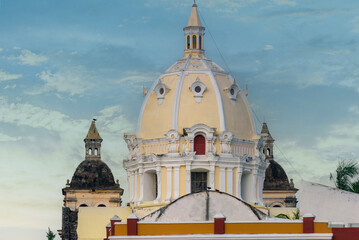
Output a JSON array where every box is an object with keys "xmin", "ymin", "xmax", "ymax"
[{"xmin": 32, "ymin": 67, "xmax": 95, "ymax": 96}]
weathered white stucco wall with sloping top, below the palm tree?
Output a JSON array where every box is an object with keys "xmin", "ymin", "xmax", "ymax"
[{"xmin": 299, "ymin": 181, "xmax": 359, "ymax": 223}]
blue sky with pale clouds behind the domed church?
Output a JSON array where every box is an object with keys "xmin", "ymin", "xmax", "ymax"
[{"xmin": 0, "ymin": 0, "xmax": 359, "ymax": 240}]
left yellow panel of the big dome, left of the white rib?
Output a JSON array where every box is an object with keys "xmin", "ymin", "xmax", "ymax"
[{"xmin": 140, "ymin": 74, "xmax": 178, "ymax": 139}]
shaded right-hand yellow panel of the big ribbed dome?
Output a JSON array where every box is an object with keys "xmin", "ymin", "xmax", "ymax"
[{"xmin": 216, "ymin": 74, "xmax": 253, "ymax": 140}]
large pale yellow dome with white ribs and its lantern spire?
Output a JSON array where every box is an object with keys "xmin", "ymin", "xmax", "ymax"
[{"xmin": 137, "ymin": 2, "xmax": 256, "ymax": 140}]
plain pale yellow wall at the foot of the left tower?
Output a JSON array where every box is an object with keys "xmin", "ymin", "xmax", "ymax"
[{"xmin": 77, "ymin": 207, "xmax": 131, "ymax": 240}]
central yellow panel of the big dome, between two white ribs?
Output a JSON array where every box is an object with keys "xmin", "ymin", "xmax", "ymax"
[{"xmin": 178, "ymin": 74, "xmax": 220, "ymax": 130}]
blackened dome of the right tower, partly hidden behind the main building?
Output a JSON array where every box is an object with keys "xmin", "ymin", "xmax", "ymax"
[{"xmin": 263, "ymin": 160, "xmax": 295, "ymax": 190}]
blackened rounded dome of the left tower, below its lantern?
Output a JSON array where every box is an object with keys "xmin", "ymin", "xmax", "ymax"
[{"xmin": 70, "ymin": 160, "xmax": 119, "ymax": 189}]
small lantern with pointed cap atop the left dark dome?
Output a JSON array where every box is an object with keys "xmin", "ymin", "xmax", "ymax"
[{"xmin": 84, "ymin": 119, "xmax": 102, "ymax": 160}]
